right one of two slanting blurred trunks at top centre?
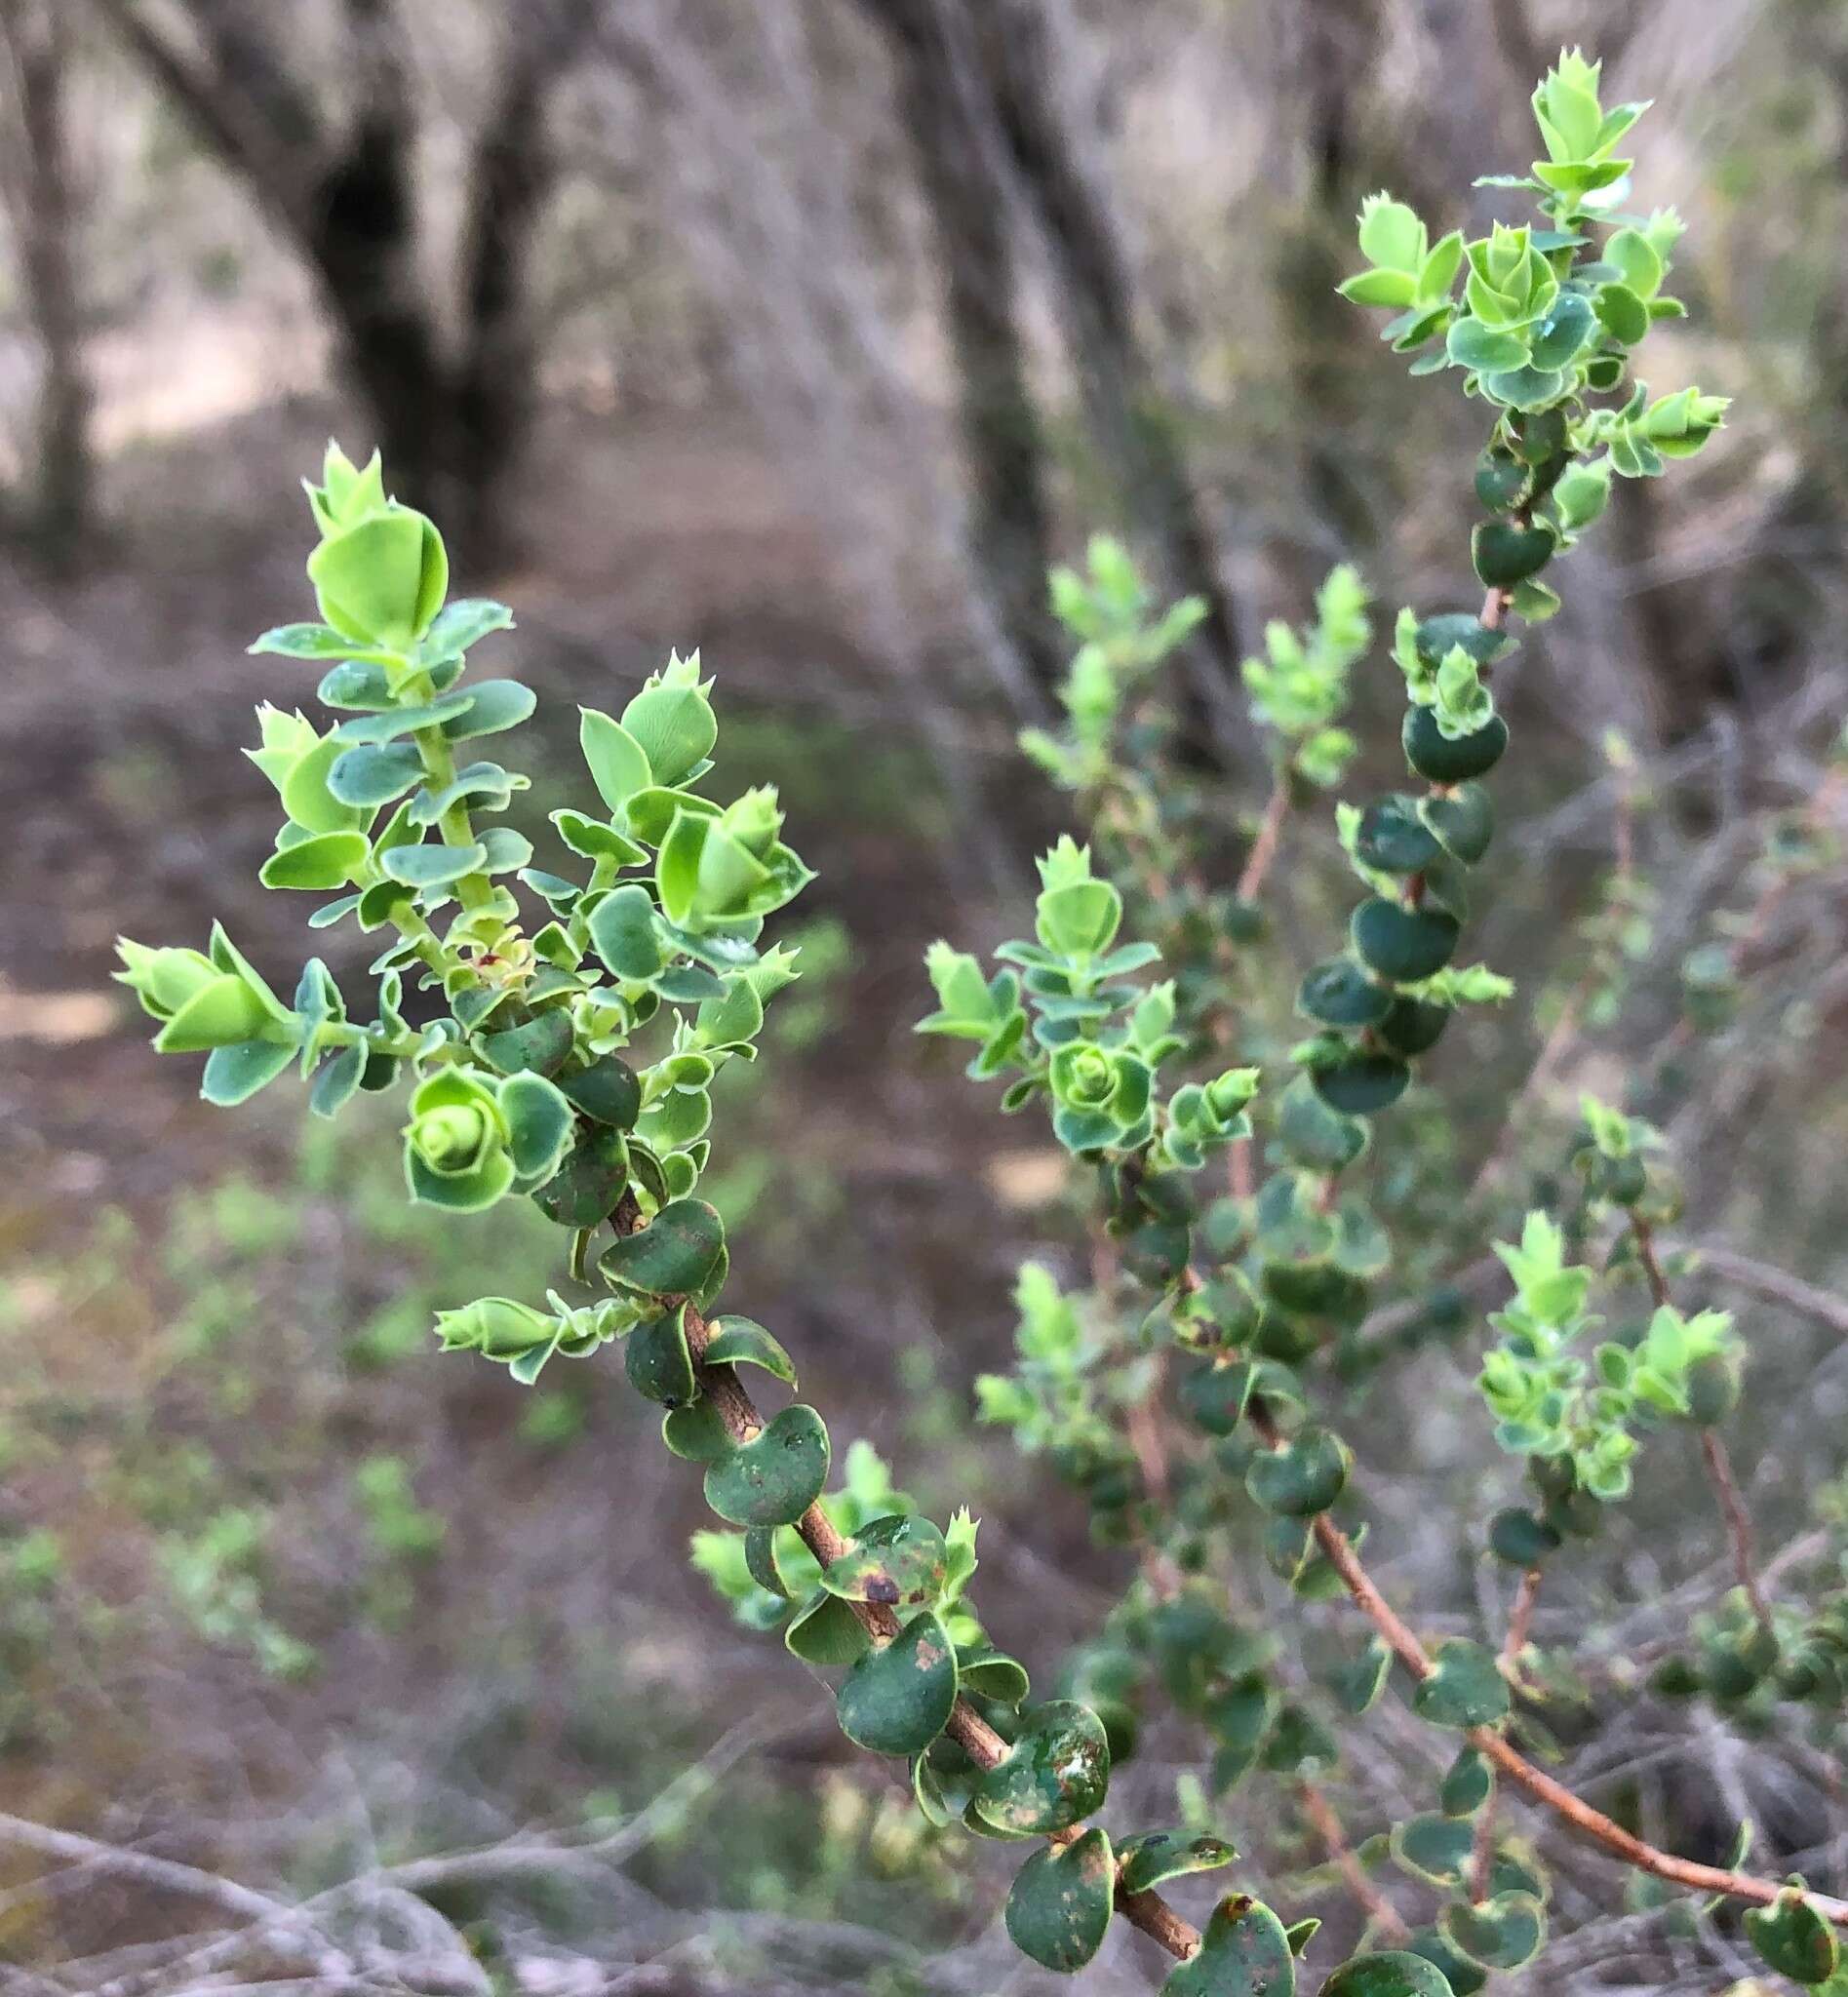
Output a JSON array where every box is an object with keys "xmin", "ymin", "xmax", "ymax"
[{"xmin": 961, "ymin": 0, "xmax": 1244, "ymax": 755}]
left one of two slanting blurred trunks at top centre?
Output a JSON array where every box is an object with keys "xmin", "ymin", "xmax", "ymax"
[{"xmin": 861, "ymin": 0, "xmax": 1065, "ymax": 693}]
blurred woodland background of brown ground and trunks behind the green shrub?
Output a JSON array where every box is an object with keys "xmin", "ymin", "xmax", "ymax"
[{"xmin": 0, "ymin": 0, "xmax": 1848, "ymax": 1997}]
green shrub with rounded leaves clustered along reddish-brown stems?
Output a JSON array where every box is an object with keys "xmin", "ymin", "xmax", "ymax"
[{"xmin": 120, "ymin": 52, "xmax": 1848, "ymax": 1997}]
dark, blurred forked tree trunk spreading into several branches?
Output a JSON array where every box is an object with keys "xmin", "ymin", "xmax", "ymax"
[{"xmin": 96, "ymin": 0, "xmax": 593, "ymax": 564}]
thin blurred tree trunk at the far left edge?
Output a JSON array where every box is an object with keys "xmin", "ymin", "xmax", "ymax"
[{"xmin": 0, "ymin": 0, "xmax": 94, "ymax": 575}]
